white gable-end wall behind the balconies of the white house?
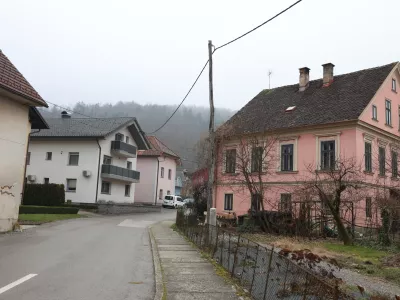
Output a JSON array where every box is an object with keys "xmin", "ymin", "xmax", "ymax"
[{"xmin": 98, "ymin": 127, "xmax": 137, "ymax": 203}]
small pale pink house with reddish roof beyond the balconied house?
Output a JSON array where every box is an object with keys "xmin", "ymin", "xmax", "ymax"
[{"xmin": 135, "ymin": 136, "xmax": 180, "ymax": 204}]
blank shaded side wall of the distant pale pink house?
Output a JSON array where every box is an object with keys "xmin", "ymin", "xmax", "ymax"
[{"xmin": 135, "ymin": 156, "xmax": 158, "ymax": 203}]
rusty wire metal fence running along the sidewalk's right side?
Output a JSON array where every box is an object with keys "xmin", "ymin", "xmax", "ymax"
[{"xmin": 177, "ymin": 219, "xmax": 354, "ymax": 300}]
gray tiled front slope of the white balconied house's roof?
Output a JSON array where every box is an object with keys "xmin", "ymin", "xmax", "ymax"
[{"xmin": 31, "ymin": 117, "xmax": 136, "ymax": 138}]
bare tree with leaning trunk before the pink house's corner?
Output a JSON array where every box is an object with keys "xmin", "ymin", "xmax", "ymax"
[{"xmin": 300, "ymin": 158, "xmax": 365, "ymax": 245}]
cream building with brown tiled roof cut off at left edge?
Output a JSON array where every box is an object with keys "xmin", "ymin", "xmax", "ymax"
[{"xmin": 0, "ymin": 50, "xmax": 48, "ymax": 232}]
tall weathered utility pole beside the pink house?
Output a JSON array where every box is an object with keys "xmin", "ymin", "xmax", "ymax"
[{"xmin": 207, "ymin": 41, "xmax": 215, "ymax": 224}]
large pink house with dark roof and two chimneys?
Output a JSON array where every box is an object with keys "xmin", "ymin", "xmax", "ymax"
[{"xmin": 213, "ymin": 62, "xmax": 400, "ymax": 226}]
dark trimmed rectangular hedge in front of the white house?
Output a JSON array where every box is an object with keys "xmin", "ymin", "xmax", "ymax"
[{"xmin": 22, "ymin": 183, "xmax": 65, "ymax": 206}]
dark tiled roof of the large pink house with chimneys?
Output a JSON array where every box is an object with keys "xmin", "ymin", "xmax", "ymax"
[{"xmin": 220, "ymin": 62, "xmax": 397, "ymax": 135}]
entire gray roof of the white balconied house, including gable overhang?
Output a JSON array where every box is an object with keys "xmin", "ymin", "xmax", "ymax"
[{"xmin": 31, "ymin": 117, "xmax": 150, "ymax": 150}]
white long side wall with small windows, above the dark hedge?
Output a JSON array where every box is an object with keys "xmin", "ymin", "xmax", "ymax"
[{"xmin": 26, "ymin": 139, "xmax": 99, "ymax": 203}]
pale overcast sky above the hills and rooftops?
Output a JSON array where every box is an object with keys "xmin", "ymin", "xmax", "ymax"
[{"xmin": 0, "ymin": 0, "xmax": 400, "ymax": 109}]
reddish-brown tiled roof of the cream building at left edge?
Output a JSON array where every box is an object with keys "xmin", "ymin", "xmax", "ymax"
[{"xmin": 0, "ymin": 50, "xmax": 47, "ymax": 107}]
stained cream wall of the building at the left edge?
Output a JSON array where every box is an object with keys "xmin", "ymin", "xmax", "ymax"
[{"xmin": 0, "ymin": 95, "xmax": 31, "ymax": 232}]
